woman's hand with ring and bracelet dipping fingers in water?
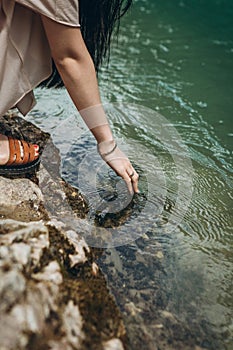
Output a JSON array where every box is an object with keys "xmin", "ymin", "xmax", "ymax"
[{"xmin": 98, "ymin": 140, "xmax": 139, "ymax": 194}]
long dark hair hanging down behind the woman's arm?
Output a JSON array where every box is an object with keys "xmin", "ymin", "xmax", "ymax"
[{"xmin": 40, "ymin": 0, "xmax": 132, "ymax": 87}]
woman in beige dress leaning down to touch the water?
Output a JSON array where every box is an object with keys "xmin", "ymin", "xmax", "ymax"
[{"xmin": 0, "ymin": 0, "xmax": 138, "ymax": 192}]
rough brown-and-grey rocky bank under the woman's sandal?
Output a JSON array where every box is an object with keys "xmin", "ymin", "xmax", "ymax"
[{"xmin": 0, "ymin": 116, "xmax": 126, "ymax": 350}]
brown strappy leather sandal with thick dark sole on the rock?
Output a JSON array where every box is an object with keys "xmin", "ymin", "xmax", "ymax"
[{"xmin": 0, "ymin": 137, "xmax": 40, "ymax": 177}]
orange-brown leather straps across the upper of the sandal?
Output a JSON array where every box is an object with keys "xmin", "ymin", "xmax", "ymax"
[{"xmin": 6, "ymin": 137, "xmax": 37, "ymax": 165}]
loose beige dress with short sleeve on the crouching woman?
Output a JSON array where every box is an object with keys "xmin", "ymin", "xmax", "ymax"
[{"xmin": 0, "ymin": 0, "xmax": 80, "ymax": 116}]
